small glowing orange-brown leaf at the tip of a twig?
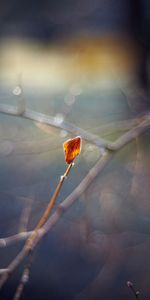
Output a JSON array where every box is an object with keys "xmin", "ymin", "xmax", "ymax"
[{"xmin": 63, "ymin": 136, "xmax": 81, "ymax": 164}]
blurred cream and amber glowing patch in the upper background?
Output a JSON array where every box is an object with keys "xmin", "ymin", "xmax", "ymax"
[{"xmin": 0, "ymin": 36, "xmax": 136, "ymax": 91}]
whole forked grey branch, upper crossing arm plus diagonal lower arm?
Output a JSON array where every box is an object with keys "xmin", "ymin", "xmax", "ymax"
[{"xmin": 0, "ymin": 99, "xmax": 150, "ymax": 287}]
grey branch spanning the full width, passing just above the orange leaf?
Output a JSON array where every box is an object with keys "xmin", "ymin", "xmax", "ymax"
[{"xmin": 0, "ymin": 102, "xmax": 150, "ymax": 151}]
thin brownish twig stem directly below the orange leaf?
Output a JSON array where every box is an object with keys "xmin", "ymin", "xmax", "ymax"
[{"xmin": 26, "ymin": 163, "xmax": 73, "ymax": 253}]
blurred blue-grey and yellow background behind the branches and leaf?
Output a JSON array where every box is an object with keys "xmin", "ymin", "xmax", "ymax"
[{"xmin": 0, "ymin": 0, "xmax": 150, "ymax": 300}]
